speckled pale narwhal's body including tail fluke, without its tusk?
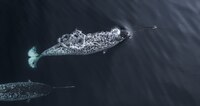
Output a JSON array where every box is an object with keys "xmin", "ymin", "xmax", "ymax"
[{"xmin": 28, "ymin": 28, "xmax": 132, "ymax": 68}]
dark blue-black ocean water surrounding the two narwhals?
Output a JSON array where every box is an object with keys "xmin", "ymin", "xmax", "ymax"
[{"xmin": 0, "ymin": 0, "xmax": 200, "ymax": 106}]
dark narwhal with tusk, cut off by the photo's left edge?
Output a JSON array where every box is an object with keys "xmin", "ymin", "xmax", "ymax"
[{"xmin": 0, "ymin": 80, "xmax": 75, "ymax": 101}]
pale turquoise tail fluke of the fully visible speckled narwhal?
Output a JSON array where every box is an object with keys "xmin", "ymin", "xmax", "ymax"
[{"xmin": 28, "ymin": 46, "xmax": 41, "ymax": 68}]
